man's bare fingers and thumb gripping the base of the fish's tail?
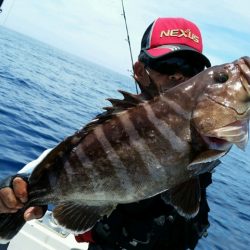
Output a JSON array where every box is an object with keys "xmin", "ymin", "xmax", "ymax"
[{"xmin": 0, "ymin": 177, "xmax": 44, "ymax": 221}]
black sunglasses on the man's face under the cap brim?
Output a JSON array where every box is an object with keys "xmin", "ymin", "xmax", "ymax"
[{"xmin": 147, "ymin": 57, "xmax": 205, "ymax": 77}]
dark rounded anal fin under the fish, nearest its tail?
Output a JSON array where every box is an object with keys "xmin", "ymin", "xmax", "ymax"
[{"xmin": 53, "ymin": 202, "xmax": 114, "ymax": 233}]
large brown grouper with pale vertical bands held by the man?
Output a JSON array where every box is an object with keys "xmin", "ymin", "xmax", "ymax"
[{"xmin": 0, "ymin": 57, "xmax": 250, "ymax": 241}]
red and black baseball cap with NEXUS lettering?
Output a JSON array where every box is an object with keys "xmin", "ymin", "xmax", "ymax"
[{"xmin": 139, "ymin": 18, "xmax": 211, "ymax": 67}]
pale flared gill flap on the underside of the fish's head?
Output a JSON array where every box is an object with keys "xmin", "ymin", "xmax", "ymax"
[{"xmin": 202, "ymin": 120, "xmax": 249, "ymax": 150}]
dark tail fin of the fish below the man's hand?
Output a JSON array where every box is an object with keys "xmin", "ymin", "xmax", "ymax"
[{"xmin": 0, "ymin": 209, "xmax": 26, "ymax": 244}]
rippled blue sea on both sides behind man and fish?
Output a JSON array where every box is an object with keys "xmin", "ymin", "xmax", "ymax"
[{"xmin": 0, "ymin": 27, "xmax": 250, "ymax": 250}]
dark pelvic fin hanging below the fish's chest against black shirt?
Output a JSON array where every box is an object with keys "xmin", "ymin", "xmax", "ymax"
[{"xmin": 161, "ymin": 178, "xmax": 201, "ymax": 218}]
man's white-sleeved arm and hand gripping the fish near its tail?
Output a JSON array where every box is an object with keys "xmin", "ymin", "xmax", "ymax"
[{"xmin": 0, "ymin": 149, "xmax": 51, "ymax": 220}]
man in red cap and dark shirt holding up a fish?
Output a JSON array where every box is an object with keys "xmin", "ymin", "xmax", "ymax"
[{"xmin": 0, "ymin": 18, "xmax": 217, "ymax": 250}]
